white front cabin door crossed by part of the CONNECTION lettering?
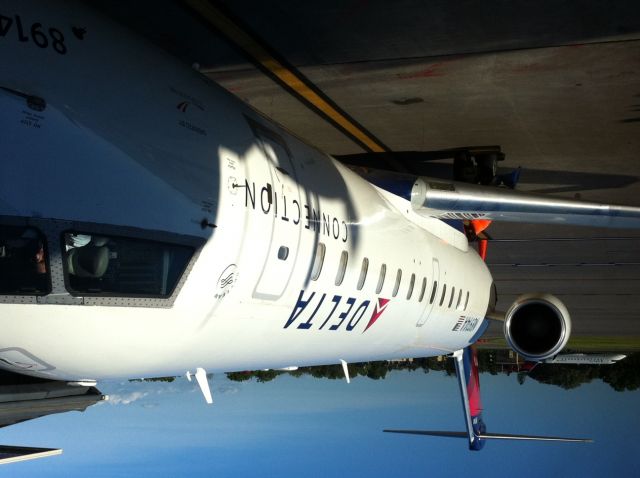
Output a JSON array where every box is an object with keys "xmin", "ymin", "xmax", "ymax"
[{"xmin": 253, "ymin": 128, "xmax": 302, "ymax": 300}]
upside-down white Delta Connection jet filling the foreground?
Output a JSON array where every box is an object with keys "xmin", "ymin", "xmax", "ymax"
[{"xmin": 0, "ymin": 1, "xmax": 640, "ymax": 449}]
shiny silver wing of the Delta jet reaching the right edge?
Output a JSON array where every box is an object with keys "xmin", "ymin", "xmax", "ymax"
[{"xmin": 405, "ymin": 177, "xmax": 640, "ymax": 229}]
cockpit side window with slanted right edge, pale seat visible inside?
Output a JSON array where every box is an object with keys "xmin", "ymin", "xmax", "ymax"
[{"xmin": 63, "ymin": 232, "xmax": 194, "ymax": 297}]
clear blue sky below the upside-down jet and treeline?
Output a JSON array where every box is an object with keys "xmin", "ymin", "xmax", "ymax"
[{"xmin": 0, "ymin": 371, "xmax": 640, "ymax": 477}]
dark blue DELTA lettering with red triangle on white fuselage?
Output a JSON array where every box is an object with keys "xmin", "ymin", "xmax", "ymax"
[{"xmin": 284, "ymin": 289, "xmax": 391, "ymax": 333}]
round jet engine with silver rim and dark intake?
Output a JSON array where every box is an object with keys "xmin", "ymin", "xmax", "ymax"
[{"xmin": 504, "ymin": 293, "xmax": 571, "ymax": 362}]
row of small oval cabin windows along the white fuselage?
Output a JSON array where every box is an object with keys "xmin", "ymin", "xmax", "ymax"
[{"xmin": 311, "ymin": 242, "xmax": 469, "ymax": 311}]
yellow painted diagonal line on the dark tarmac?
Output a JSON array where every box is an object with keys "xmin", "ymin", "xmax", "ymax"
[{"xmin": 183, "ymin": 0, "xmax": 386, "ymax": 153}]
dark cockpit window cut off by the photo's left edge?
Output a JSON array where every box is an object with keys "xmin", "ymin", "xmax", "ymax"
[{"xmin": 0, "ymin": 225, "xmax": 51, "ymax": 295}]
